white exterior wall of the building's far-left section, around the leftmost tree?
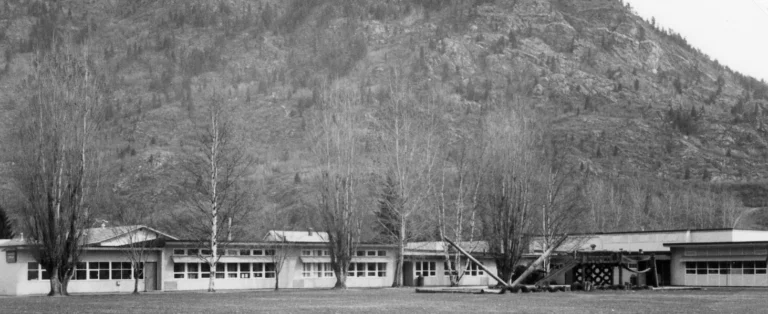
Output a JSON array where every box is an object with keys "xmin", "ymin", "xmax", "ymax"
[{"xmin": 0, "ymin": 250, "xmax": 157, "ymax": 295}]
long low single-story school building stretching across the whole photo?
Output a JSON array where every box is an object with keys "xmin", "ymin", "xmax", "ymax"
[{"xmin": 0, "ymin": 226, "xmax": 768, "ymax": 295}]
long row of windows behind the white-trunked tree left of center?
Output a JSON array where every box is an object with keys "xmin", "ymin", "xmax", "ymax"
[{"xmin": 173, "ymin": 263, "xmax": 275, "ymax": 279}]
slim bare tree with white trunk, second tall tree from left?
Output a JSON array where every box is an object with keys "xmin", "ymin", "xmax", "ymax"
[{"xmin": 179, "ymin": 95, "xmax": 252, "ymax": 292}]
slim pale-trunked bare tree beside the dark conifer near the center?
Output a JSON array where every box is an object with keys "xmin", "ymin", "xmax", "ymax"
[{"xmin": 376, "ymin": 84, "xmax": 439, "ymax": 287}]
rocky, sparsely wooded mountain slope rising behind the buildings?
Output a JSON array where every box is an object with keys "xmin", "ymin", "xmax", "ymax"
[{"xmin": 0, "ymin": 0, "xmax": 768, "ymax": 234}]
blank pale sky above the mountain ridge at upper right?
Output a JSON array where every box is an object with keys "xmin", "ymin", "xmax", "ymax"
[{"xmin": 624, "ymin": 0, "xmax": 768, "ymax": 82}]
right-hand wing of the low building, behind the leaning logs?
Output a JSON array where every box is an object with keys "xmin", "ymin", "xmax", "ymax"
[{"xmin": 525, "ymin": 228, "xmax": 768, "ymax": 286}]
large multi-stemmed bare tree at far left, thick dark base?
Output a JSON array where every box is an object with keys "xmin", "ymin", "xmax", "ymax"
[{"xmin": 12, "ymin": 44, "xmax": 101, "ymax": 296}]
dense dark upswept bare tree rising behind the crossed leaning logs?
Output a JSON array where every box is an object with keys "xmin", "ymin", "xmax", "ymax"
[{"xmin": 480, "ymin": 101, "xmax": 541, "ymax": 282}]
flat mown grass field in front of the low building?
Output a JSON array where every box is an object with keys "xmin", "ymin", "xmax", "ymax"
[{"xmin": 0, "ymin": 289, "xmax": 768, "ymax": 313}]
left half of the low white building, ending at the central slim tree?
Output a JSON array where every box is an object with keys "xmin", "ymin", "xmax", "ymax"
[{"xmin": 0, "ymin": 226, "xmax": 396, "ymax": 295}]
